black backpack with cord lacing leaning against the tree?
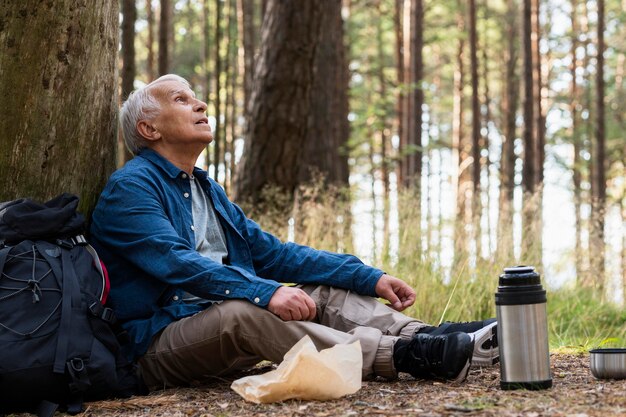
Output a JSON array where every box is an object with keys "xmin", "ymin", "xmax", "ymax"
[{"xmin": 0, "ymin": 194, "xmax": 144, "ymax": 416}]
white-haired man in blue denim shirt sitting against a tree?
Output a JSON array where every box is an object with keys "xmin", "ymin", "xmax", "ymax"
[{"xmin": 91, "ymin": 75, "xmax": 498, "ymax": 389}]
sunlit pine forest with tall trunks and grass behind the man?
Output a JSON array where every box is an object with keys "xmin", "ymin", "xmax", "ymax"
[{"xmin": 0, "ymin": 0, "xmax": 626, "ymax": 349}]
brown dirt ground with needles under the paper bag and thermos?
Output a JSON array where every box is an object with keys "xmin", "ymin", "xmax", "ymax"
[{"xmin": 36, "ymin": 353, "xmax": 626, "ymax": 417}]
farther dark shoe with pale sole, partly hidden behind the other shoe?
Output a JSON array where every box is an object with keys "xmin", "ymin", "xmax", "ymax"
[{"xmin": 417, "ymin": 318, "xmax": 500, "ymax": 366}]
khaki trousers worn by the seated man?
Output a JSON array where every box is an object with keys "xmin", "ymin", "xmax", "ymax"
[{"xmin": 139, "ymin": 285, "xmax": 425, "ymax": 389}]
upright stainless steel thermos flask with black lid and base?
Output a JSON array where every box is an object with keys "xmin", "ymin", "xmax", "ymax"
[{"xmin": 496, "ymin": 266, "xmax": 552, "ymax": 390}]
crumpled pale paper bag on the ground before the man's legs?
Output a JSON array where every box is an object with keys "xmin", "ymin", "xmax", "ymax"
[{"xmin": 230, "ymin": 336, "xmax": 363, "ymax": 404}]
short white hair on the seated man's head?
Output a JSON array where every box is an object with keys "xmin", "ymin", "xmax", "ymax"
[{"xmin": 120, "ymin": 74, "xmax": 191, "ymax": 155}]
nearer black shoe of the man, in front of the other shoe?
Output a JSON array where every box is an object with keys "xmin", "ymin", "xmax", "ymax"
[{"xmin": 393, "ymin": 332, "xmax": 474, "ymax": 382}]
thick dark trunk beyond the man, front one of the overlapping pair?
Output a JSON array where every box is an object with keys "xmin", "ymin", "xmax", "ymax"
[{"xmin": 234, "ymin": 0, "xmax": 327, "ymax": 202}]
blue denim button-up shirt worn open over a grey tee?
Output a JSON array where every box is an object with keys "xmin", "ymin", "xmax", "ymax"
[{"xmin": 90, "ymin": 149, "xmax": 383, "ymax": 357}]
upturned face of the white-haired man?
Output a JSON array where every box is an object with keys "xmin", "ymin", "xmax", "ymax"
[{"xmin": 152, "ymin": 81, "xmax": 213, "ymax": 145}]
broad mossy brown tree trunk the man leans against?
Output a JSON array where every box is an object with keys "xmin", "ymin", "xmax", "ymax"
[{"xmin": 0, "ymin": 0, "xmax": 119, "ymax": 216}]
